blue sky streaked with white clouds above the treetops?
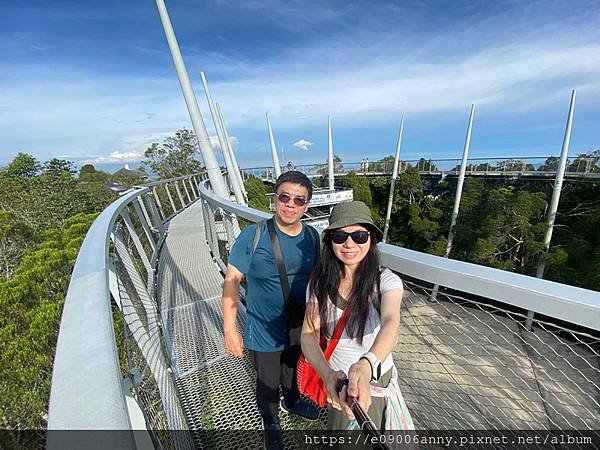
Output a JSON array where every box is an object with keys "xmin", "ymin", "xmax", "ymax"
[{"xmin": 0, "ymin": 0, "xmax": 600, "ymax": 172}]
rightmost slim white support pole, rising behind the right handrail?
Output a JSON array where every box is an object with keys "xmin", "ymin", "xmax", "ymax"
[{"xmin": 526, "ymin": 89, "xmax": 575, "ymax": 330}]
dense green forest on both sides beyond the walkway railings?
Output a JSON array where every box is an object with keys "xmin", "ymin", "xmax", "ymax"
[{"xmin": 0, "ymin": 129, "xmax": 600, "ymax": 448}]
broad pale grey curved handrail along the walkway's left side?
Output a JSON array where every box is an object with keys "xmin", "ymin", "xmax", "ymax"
[{"xmin": 48, "ymin": 175, "xmax": 199, "ymax": 442}]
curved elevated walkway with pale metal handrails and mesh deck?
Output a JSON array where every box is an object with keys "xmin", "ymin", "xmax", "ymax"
[{"xmin": 49, "ymin": 173, "xmax": 600, "ymax": 449}]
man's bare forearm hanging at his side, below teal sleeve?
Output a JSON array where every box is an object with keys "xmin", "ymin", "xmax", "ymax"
[{"xmin": 221, "ymin": 264, "xmax": 244, "ymax": 356}]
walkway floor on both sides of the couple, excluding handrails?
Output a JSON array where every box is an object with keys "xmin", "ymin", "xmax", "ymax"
[{"xmin": 158, "ymin": 203, "xmax": 600, "ymax": 448}]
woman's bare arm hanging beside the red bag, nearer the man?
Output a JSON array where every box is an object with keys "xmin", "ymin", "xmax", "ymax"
[{"xmin": 300, "ymin": 301, "xmax": 346, "ymax": 410}]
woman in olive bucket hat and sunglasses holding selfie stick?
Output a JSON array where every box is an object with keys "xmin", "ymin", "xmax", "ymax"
[{"xmin": 301, "ymin": 201, "xmax": 414, "ymax": 430}]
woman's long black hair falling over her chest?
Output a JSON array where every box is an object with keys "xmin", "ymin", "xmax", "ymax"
[{"xmin": 309, "ymin": 224, "xmax": 379, "ymax": 345}]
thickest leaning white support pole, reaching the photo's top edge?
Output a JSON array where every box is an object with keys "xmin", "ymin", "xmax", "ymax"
[{"xmin": 156, "ymin": 0, "xmax": 229, "ymax": 198}]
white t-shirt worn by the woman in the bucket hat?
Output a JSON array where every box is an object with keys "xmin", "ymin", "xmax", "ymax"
[{"xmin": 308, "ymin": 268, "xmax": 404, "ymax": 374}]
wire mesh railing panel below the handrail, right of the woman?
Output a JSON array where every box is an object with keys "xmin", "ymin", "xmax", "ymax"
[{"xmin": 394, "ymin": 283, "xmax": 600, "ymax": 430}]
